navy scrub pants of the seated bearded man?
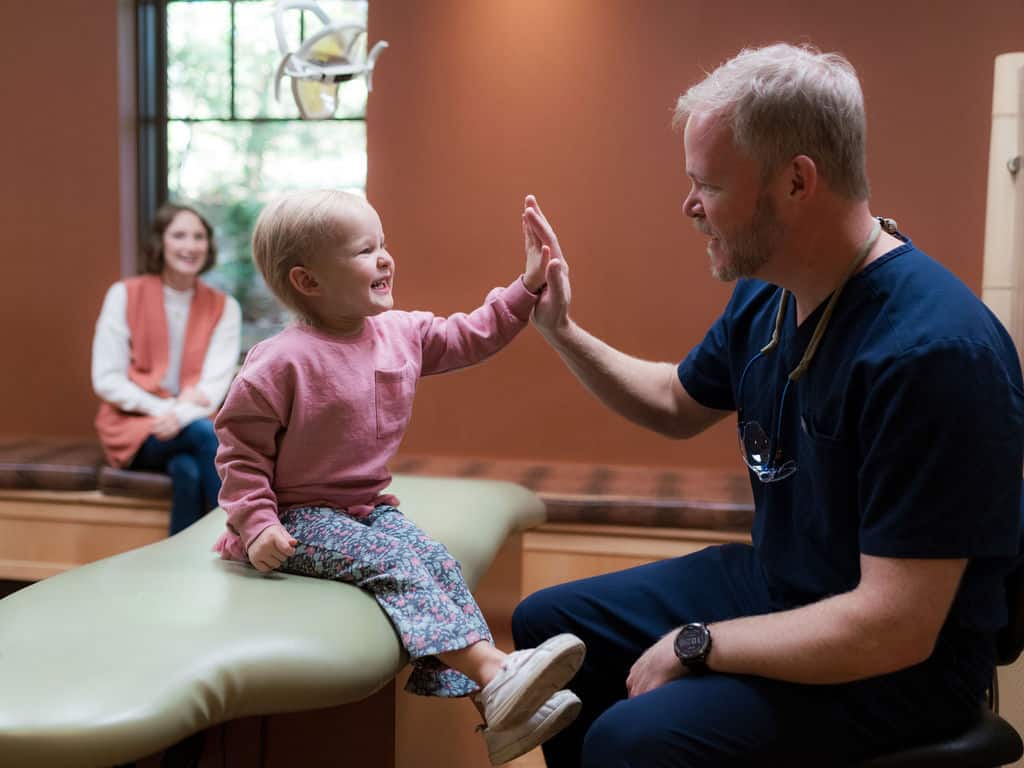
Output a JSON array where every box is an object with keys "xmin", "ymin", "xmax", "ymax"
[{"xmin": 512, "ymin": 544, "xmax": 991, "ymax": 768}]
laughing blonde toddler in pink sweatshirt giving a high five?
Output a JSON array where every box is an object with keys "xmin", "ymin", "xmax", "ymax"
[{"xmin": 215, "ymin": 190, "xmax": 585, "ymax": 765}]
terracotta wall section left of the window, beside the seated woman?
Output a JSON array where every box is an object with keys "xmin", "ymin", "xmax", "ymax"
[{"xmin": 0, "ymin": 0, "xmax": 134, "ymax": 435}]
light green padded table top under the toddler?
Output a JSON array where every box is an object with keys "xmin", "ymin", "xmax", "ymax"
[{"xmin": 0, "ymin": 476, "xmax": 544, "ymax": 768}]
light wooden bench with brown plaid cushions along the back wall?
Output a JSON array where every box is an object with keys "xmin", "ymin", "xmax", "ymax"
[{"xmin": 0, "ymin": 437, "xmax": 754, "ymax": 594}]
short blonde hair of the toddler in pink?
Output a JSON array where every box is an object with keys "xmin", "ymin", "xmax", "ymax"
[{"xmin": 252, "ymin": 189, "xmax": 368, "ymax": 325}]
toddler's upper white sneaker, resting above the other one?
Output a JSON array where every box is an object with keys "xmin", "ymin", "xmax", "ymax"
[{"xmin": 476, "ymin": 634, "xmax": 587, "ymax": 730}]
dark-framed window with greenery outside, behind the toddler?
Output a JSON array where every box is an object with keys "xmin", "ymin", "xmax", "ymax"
[{"xmin": 138, "ymin": 0, "xmax": 367, "ymax": 349}]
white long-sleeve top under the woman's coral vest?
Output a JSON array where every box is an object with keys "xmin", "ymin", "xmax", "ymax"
[{"xmin": 92, "ymin": 282, "xmax": 242, "ymax": 427}]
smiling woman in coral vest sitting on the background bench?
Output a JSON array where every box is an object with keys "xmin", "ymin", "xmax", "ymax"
[{"xmin": 92, "ymin": 204, "xmax": 242, "ymax": 535}]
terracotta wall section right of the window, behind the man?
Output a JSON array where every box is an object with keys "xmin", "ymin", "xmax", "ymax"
[{"xmin": 369, "ymin": 0, "xmax": 1024, "ymax": 465}]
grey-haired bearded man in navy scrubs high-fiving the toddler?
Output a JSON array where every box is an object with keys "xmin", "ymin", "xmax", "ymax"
[{"xmin": 513, "ymin": 45, "xmax": 1024, "ymax": 768}]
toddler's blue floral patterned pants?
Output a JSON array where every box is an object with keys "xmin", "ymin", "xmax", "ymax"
[{"xmin": 281, "ymin": 505, "xmax": 494, "ymax": 696}]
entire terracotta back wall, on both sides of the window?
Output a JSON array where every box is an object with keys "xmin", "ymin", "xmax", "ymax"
[{"xmin": 0, "ymin": 0, "xmax": 1024, "ymax": 465}]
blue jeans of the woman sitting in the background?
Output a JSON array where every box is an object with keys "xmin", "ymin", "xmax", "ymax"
[{"xmin": 128, "ymin": 419, "xmax": 220, "ymax": 536}]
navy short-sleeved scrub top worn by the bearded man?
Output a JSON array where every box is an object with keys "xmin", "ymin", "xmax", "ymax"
[{"xmin": 678, "ymin": 236, "xmax": 1024, "ymax": 634}]
